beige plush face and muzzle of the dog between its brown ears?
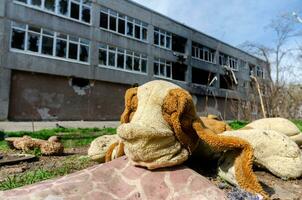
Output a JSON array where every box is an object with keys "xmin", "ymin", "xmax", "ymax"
[{"xmin": 117, "ymin": 80, "xmax": 189, "ymax": 169}]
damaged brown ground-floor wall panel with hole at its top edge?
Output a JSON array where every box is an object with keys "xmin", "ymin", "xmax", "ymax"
[{"xmin": 9, "ymin": 71, "xmax": 130, "ymax": 121}]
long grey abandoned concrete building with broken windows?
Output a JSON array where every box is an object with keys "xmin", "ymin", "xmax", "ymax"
[{"xmin": 0, "ymin": 0, "xmax": 267, "ymax": 121}]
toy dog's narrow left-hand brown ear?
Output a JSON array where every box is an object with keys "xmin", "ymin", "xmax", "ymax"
[{"xmin": 121, "ymin": 87, "xmax": 138, "ymax": 124}]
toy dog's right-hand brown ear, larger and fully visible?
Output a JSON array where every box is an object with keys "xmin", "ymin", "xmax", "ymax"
[{"xmin": 162, "ymin": 89, "xmax": 199, "ymax": 154}]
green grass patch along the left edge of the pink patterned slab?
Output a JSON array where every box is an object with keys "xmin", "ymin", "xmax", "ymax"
[{"xmin": 0, "ymin": 156, "xmax": 90, "ymax": 190}]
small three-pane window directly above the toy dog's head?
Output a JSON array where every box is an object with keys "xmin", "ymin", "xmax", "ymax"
[{"xmin": 153, "ymin": 58, "xmax": 172, "ymax": 79}]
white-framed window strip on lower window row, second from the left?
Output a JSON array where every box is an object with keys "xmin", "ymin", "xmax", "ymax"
[{"xmin": 99, "ymin": 44, "xmax": 147, "ymax": 73}]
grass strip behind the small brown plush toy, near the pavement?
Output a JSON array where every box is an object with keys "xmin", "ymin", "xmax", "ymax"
[{"xmin": 0, "ymin": 128, "xmax": 116, "ymax": 151}]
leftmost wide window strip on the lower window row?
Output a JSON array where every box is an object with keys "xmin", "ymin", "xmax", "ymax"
[{"xmin": 11, "ymin": 22, "xmax": 90, "ymax": 63}]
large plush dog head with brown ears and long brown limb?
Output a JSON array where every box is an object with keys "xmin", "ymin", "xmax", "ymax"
[{"xmin": 106, "ymin": 80, "xmax": 268, "ymax": 198}]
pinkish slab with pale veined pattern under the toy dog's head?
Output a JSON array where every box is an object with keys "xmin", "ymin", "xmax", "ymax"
[{"xmin": 0, "ymin": 157, "xmax": 226, "ymax": 200}]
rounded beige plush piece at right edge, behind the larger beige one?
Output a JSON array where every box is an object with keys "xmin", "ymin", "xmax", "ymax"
[{"xmin": 243, "ymin": 118, "xmax": 302, "ymax": 146}]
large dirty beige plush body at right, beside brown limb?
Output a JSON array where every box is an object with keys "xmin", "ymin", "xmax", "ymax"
[{"xmin": 219, "ymin": 129, "xmax": 302, "ymax": 178}]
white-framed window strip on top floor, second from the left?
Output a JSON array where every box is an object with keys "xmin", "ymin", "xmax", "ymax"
[{"xmin": 100, "ymin": 8, "xmax": 148, "ymax": 41}]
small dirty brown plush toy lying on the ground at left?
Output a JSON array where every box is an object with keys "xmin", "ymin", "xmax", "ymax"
[{"xmin": 5, "ymin": 135, "xmax": 64, "ymax": 156}]
